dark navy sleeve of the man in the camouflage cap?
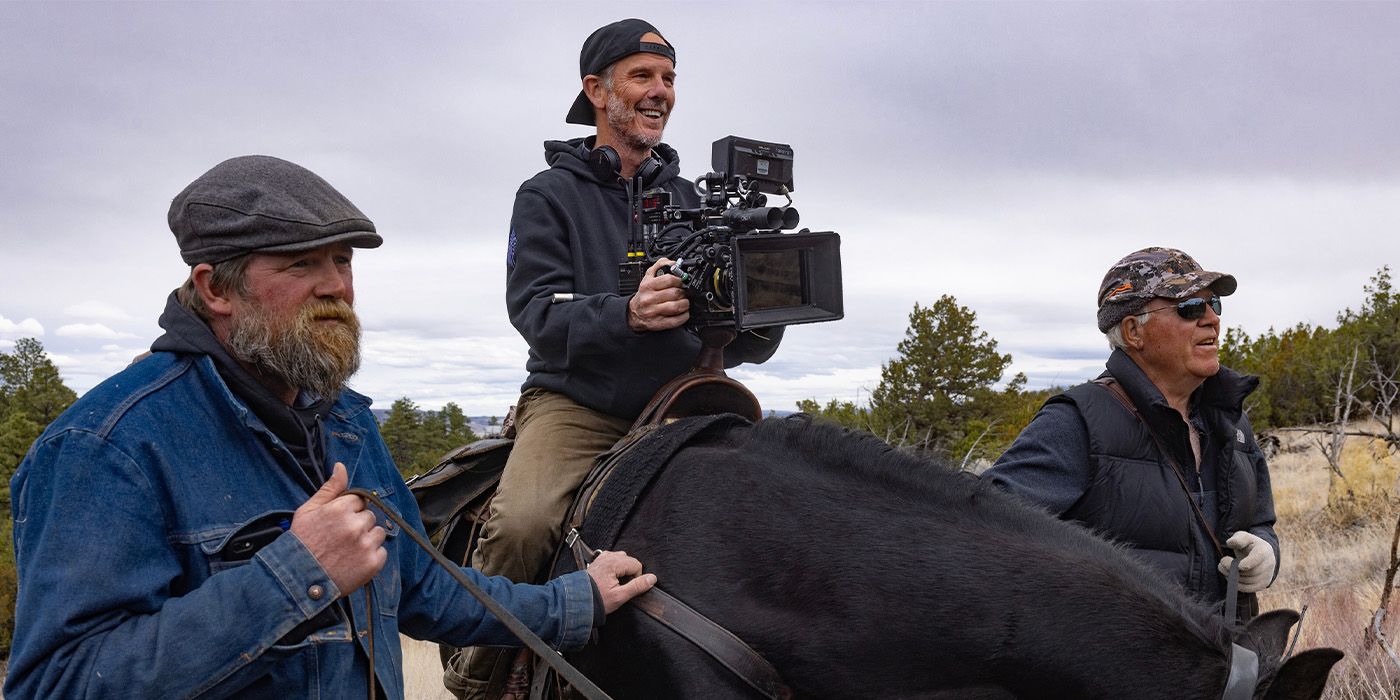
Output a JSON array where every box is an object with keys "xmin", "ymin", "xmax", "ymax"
[{"xmin": 981, "ymin": 402, "xmax": 1093, "ymax": 515}]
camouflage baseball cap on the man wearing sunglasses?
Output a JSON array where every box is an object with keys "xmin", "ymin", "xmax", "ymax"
[{"xmin": 1099, "ymin": 246, "xmax": 1238, "ymax": 333}]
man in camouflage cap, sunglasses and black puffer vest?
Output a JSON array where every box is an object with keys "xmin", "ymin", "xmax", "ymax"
[{"xmin": 983, "ymin": 248, "xmax": 1278, "ymax": 619}]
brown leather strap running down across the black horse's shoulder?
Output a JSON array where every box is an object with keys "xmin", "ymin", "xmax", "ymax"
[{"xmin": 564, "ymin": 529, "xmax": 792, "ymax": 700}]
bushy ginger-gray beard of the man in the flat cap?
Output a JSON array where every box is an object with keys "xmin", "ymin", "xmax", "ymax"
[{"xmin": 228, "ymin": 305, "xmax": 360, "ymax": 399}]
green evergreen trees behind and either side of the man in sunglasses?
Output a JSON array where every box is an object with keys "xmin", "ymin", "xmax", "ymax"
[{"xmin": 797, "ymin": 266, "xmax": 1400, "ymax": 465}]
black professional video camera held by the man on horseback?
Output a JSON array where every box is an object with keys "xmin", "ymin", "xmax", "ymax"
[{"xmin": 622, "ymin": 136, "xmax": 844, "ymax": 330}]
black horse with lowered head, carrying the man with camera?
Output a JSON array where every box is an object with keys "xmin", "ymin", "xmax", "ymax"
[{"xmin": 548, "ymin": 417, "xmax": 1341, "ymax": 699}]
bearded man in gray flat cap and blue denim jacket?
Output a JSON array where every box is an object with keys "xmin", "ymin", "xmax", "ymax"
[{"xmin": 4, "ymin": 155, "xmax": 655, "ymax": 699}]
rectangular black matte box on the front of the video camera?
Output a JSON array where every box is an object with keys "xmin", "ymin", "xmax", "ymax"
[{"xmin": 734, "ymin": 231, "xmax": 844, "ymax": 330}]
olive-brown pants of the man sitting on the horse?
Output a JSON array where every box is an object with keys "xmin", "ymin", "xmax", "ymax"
[{"xmin": 442, "ymin": 388, "xmax": 631, "ymax": 699}]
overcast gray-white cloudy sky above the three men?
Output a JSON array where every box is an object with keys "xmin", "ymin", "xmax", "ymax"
[{"xmin": 0, "ymin": 0, "xmax": 1400, "ymax": 414}]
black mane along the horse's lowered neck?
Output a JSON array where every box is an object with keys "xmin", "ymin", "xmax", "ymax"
[{"xmin": 731, "ymin": 413, "xmax": 1238, "ymax": 654}]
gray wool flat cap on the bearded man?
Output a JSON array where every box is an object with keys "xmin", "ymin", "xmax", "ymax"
[{"xmin": 169, "ymin": 155, "xmax": 384, "ymax": 265}]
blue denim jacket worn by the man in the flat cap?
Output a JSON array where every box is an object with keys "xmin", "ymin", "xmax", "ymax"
[{"xmin": 4, "ymin": 353, "xmax": 594, "ymax": 699}]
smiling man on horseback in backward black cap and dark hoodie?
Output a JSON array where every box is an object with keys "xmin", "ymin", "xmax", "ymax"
[{"xmin": 447, "ymin": 20, "xmax": 783, "ymax": 697}]
